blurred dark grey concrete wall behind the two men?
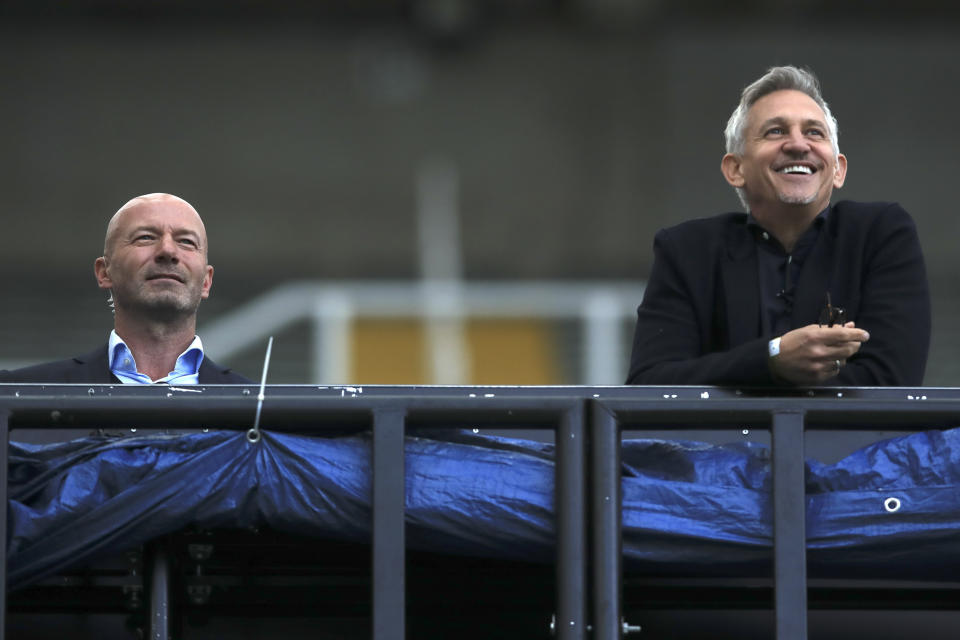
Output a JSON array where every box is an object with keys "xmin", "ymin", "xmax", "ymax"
[{"xmin": 0, "ymin": 12, "xmax": 960, "ymax": 385}]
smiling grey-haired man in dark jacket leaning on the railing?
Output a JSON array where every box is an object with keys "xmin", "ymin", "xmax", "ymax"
[{"xmin": 627, "ymin": 66, "xmax": 930, "ymax": 386}]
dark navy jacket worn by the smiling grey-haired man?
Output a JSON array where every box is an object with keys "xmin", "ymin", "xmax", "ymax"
[{"xmin": 627, "ymin": 201, "xmax": 930, "ymax": 386}]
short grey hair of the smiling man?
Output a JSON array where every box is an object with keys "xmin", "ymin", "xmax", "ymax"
[{"xmin": 723, "ymin": 66, "xmax": 840, "ymax": 210}]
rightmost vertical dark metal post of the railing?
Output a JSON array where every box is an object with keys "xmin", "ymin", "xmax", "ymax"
[{"xmin": 772, "ymin": 411, "xmax": 807, "ymax": 640}]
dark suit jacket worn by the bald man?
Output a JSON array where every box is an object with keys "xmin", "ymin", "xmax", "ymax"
[{"xmin": 0, "ymin": 344, "xmax": 251, "ymax": 384}]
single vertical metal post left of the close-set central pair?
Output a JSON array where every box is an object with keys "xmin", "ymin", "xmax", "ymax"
[{"xmin": 373, "ymin": 409, "xmax": 406, "ymax": 640}]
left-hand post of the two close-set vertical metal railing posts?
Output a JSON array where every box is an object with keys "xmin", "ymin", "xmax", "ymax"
[{"xmin": 556, "ymin": 402, "xmax": 587, "ymax": 640}]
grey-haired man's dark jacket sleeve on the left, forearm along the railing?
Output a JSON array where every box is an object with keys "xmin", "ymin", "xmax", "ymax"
[{"xmin": 627, "ymin": 230, "xmax": 774, "ymax": 386}]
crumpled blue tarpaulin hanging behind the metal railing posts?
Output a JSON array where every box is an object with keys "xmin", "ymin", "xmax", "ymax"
[{"xmin": 7, "ymin": 430, "xmax": 960, "ymax": 588}]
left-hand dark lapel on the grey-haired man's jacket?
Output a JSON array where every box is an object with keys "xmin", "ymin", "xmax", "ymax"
[{"xmin": 721, "ymin": 217, "xmax": 760, "ymax": 346}]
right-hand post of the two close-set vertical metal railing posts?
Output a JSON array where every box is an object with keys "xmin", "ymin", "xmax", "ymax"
[{"xmin": 590, "ymin": 402, "xmax": 623, "ymax": 640}]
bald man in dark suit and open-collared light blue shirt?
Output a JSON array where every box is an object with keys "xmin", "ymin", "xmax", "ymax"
[{"xmin": 0, "ymin": 193, "xmax": 250, "ymax": 385}]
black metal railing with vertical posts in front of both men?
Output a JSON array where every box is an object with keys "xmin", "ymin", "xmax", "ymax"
[{"xmin": 0, "ymin": 385, "xmax": 960, "ymax": 640}]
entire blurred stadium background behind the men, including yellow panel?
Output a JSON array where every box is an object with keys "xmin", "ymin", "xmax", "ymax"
[{"xmin": 0, "ymin": 0, "xmax": 960, "ymax": 386}]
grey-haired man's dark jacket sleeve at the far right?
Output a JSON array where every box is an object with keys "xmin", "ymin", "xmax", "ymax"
[{"xmin": 834, "ymin": 204, "xmax": 931, "ymax": 387}]
